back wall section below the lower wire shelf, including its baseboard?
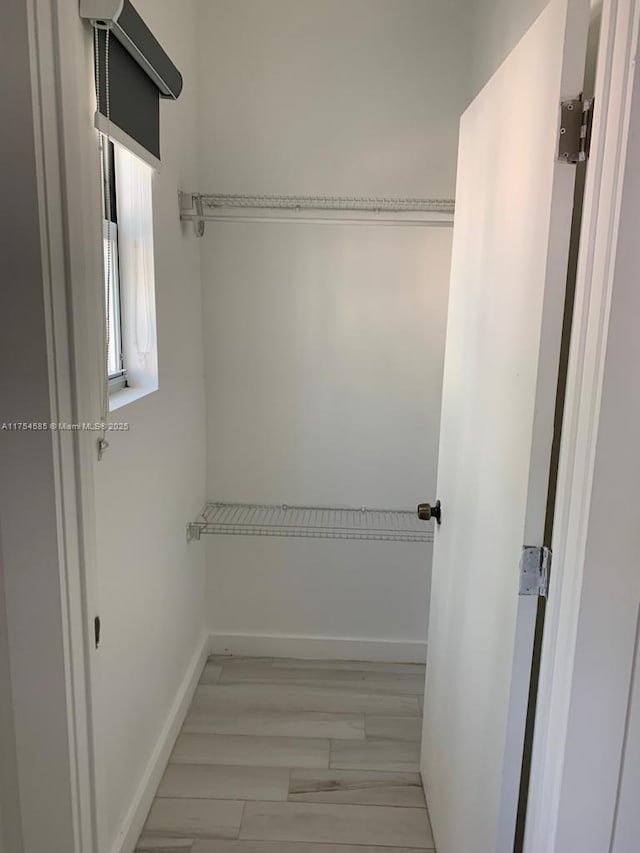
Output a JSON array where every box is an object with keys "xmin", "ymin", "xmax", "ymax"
[{"xmin": 207, "ymin": 536, "xmax": 431, "ymax": 662}]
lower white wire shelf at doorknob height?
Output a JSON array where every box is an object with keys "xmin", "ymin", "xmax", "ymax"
[{"xmin": 187, "ymin": 503, "xmax": 433, "ymax": 542}]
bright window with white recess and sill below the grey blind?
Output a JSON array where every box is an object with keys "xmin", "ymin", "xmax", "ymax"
[{"xmin": 101, "ymin": 136, "xmax": 158, "ymax": 411}]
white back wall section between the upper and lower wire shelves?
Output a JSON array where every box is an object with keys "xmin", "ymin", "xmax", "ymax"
[{"xmin": 202, "ymin": 223, "xmax": 451, "ymax": 508}]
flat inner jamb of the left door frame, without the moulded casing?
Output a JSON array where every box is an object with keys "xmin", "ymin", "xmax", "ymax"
[{"xmin": 49, "ymin": 0, "xmax": 112, "ymax": 853}]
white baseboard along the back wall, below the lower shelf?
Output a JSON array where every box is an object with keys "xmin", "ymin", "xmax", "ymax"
[{"xmin": 209, "ymin": 634, "xmax": 427, "ymax": 663}]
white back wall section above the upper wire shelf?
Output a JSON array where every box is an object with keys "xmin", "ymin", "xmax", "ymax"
[{"xmin": 199, "ymin": 0, "xmax": 472, "ymax": 198}]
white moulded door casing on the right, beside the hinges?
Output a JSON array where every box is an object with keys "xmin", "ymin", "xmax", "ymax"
[{"xmin": 524, "ymin": 0, "xmax": 640, "ymax": 853}]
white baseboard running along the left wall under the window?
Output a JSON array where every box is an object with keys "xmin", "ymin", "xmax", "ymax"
[{"xmin": 111, "ymin": 634, "xmax": 210, "ymax": 853}]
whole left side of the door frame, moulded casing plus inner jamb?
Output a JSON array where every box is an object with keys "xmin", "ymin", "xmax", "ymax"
[{"xmin": 19, "ymin": 0, "xmax": 104, "ymax": 853}]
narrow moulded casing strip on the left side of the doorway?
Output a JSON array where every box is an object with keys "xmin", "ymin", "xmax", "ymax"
[{"xmin": 27, "ymin": 0, "xmax": 97, "ymax": 853}]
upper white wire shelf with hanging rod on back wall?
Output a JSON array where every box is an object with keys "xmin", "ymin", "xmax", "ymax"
[{"xmin": 179, "ymin": 192, "xmax": 455, "ymax": 237}]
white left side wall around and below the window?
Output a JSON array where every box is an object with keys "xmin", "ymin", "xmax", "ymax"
[{"xmin": 88, "ymin": 0, "xmax": 205, "ymax": 851}]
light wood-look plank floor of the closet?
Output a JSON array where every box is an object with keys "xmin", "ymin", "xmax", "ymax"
[{"xmin": 137, "ymin": 657, "xmax": 433, "ymax": 853}]
